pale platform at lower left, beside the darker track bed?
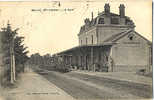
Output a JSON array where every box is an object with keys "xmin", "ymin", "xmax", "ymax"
[{"xmin": 0, "ymin": 68, "xmax": 73, "ymax": 100}]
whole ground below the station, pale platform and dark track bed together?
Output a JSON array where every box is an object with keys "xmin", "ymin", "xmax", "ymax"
[{"xmin": 0, "ymin": 65, "xmax": 152, "ymax": 100}]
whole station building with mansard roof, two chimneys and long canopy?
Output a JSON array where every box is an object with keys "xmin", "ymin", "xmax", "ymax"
[{"xmin": 55, "ymin": 4, "xmax": 152, "ymax": 72}]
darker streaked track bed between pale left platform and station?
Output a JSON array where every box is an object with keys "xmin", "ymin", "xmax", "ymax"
[{"xmin": 40, "ymin": 71, "xmax": 152, "ymax": 100}]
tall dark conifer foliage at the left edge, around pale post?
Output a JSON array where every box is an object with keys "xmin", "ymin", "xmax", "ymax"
[{"xmin": 1, "ymin": 24, "xmax": 28, "ymax": 83}]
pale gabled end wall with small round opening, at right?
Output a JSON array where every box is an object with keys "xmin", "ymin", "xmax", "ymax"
[{"xmin": 112, "ymin": 32, "xmax": 150, "ymax": 71}]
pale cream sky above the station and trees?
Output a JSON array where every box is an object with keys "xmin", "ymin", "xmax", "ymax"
[{"xmin": 0, "ymin": 0, "xmax": 152, "ymax": 55}]
